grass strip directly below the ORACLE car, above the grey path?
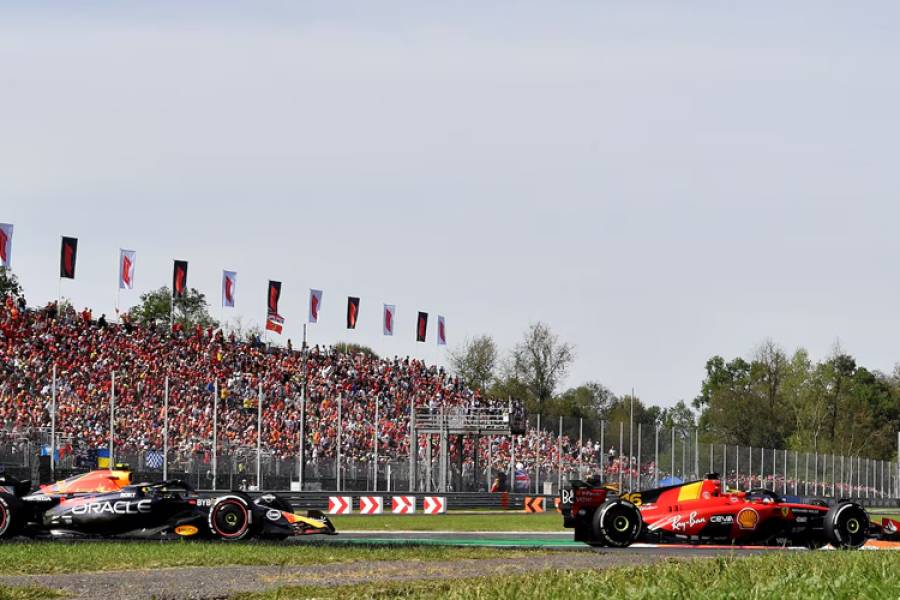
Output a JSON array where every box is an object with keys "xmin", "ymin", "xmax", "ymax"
[{"xmin": 0, "ymin": 541, "xmax": 552, "ymax": 575}]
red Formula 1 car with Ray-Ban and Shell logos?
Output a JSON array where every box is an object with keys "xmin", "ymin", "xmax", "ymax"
[{"xmin": 560, "ymin": 474, "xmax": 900, "ymax": 548}]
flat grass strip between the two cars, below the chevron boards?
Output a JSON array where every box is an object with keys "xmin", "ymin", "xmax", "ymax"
[{"xmin": 330, "ymin": 511, "xmax": 565, "ymax": 532}]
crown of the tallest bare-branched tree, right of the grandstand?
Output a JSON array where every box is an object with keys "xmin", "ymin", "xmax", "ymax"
[{"xmin": 508, "ymin": 322, "xmax": 575, "ymax": 413}]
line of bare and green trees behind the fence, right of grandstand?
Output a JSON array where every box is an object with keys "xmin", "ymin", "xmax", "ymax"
[{"xmin": 450, "ymin": 323, "xmax": 900, "ymax": 460}]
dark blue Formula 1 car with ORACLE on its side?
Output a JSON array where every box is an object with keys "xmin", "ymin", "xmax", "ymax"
[{"xmin": 0, "ymin": 469, "xmax": 335, "ymax": 541}]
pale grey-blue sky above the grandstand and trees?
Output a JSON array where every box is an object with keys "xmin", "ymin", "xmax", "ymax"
[{"xmin": 0, "ymin": 2, "xmax": 900, "ymax": 404}]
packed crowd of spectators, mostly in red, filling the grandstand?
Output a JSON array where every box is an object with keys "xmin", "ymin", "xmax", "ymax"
[{"xmin": 0, "ymin": 298, "xmax": 596, "ymax": 468}]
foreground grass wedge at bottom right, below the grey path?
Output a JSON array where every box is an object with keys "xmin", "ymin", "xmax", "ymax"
[{"xmin": 235, "ymin": 551, "xmax": 900, "ymax": 600}]
